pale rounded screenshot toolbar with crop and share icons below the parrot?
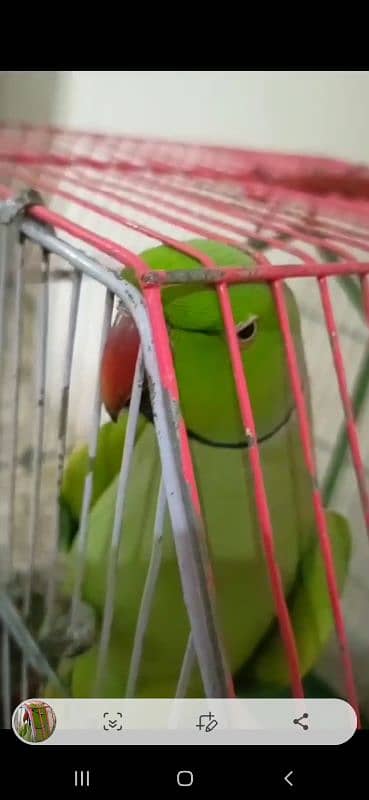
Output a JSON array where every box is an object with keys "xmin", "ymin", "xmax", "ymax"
[{"xmin": 13, "ymin": 698, "xmax": 357, "ymax": 746}]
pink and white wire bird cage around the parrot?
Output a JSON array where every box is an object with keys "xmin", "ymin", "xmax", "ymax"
[{"xmin": 0, "ymin": 125, "xmax": 369, "ymax": 727}]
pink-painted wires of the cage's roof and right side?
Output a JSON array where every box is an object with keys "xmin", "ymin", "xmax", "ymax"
[{"xmin": 0, "ymin": 124, "xmax": 369, "ymax": 726}]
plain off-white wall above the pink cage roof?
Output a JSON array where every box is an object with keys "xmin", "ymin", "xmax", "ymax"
[{"xmin": 54, "ymin": 70, "xmax": 369, "ymax": 160}]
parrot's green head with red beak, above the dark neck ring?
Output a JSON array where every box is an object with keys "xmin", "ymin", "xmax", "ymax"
[{"xmin": 101, "ymin": 239, "xmax": 302, "ymax": 447}]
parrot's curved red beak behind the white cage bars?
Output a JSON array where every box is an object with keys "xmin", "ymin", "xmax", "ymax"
[{"xmin": 100, "ymin": 310, "xmax": 140, "ymax": 422}]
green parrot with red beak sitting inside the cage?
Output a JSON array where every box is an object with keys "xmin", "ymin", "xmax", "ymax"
[{"xmin": 45, "ymin": 239, "xmax": 351, "ymax": 698}]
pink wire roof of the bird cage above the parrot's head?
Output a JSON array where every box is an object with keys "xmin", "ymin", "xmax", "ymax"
[{"xmin": 0, "ymin": 123, "xmax": 369, "ymax": 280}]
